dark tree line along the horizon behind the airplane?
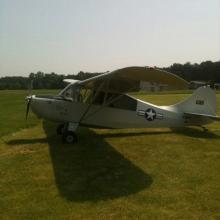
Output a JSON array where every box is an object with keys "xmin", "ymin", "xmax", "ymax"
[{"xmin": 0, "ymin": 61, "xmax": 220, "ymax": 90}]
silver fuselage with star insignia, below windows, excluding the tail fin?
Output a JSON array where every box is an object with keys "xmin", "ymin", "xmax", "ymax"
[{"xmin": 31, "ymin": 96, "xmax": 205, "ymax": 128}]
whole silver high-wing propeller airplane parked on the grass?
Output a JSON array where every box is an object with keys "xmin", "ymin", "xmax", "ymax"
[{"xmin": 26, "ymin": 66, "xmax": 220, "ymax": 143}]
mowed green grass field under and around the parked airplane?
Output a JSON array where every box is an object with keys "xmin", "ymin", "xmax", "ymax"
[{"xmin": 0, "ymin": 91, "xmax": 220, "ymax": 219}]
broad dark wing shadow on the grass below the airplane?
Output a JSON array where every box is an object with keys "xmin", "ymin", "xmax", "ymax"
[{"xmin": 43, "ymin": 121, "xmax": 152, "ymax": 202}]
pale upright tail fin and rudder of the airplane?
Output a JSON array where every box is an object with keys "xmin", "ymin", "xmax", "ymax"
[{"xmin": 174, "ymin": 86, "xmax": 220, "ymax": 121}]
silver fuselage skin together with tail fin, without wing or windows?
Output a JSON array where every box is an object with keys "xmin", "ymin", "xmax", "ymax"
[{"xmin": 29, "ymin": 87, "xmax": 216, "ymax": 131}]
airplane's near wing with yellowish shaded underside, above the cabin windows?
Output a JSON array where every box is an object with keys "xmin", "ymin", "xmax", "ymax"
[{"xmin": 77, "ymin": 67, "xmax": 188, "ymax": 93}]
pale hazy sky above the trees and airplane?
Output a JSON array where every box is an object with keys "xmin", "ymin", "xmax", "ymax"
[{"xmin": 0, "ymin": 0, "xmax": 220, "ymax": 77}]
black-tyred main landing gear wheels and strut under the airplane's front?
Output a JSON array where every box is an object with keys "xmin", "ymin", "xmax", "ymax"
[{"xmin": 57, "ymin": 122, "xmax": 78, "ymax": 144}]
